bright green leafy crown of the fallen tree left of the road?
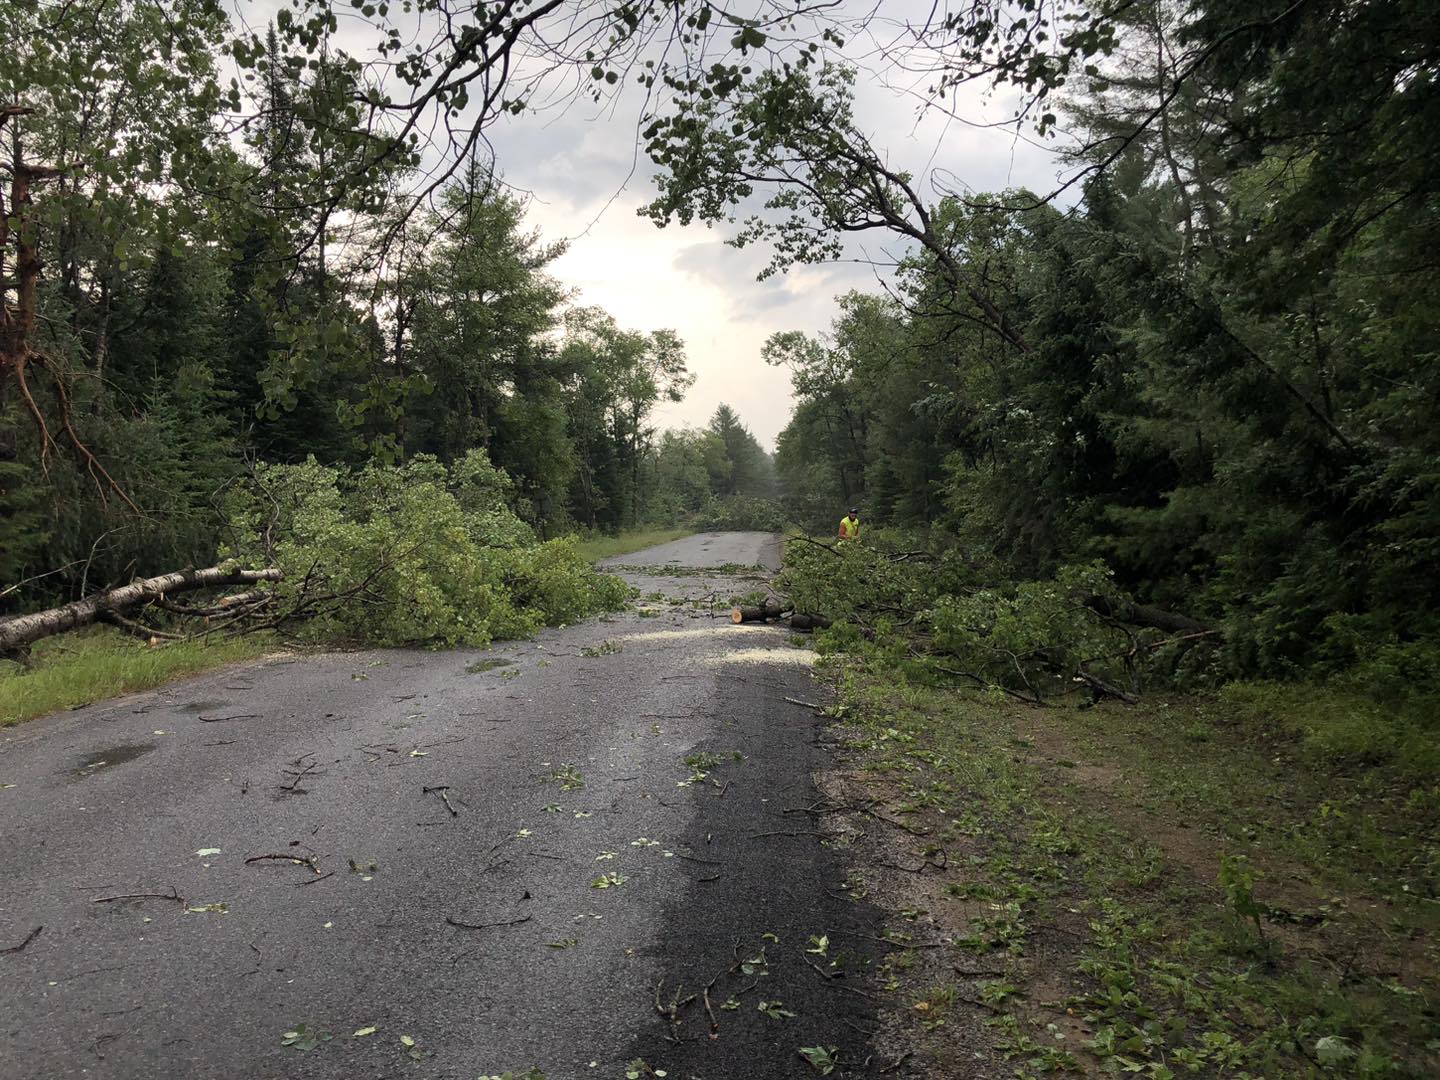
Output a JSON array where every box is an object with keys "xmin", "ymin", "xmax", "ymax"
[{"xmin": 228, "ymin": 451, "xmax": 628, "ymax": 645}]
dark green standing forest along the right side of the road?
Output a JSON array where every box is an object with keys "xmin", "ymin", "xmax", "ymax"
[{"xmin": 748, "ymin": 3, "xmax": 1440, "ymax": 690}]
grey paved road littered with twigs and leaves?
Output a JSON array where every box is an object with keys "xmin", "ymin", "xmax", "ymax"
[{"xmin": 0, "ymin": 533, "xmax": 903, "ymax": 1080}]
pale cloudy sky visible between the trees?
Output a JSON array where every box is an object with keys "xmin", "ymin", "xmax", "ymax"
[{"xmin": 232, "ymin": 0, "xmax": 1057, "ymax": 448}]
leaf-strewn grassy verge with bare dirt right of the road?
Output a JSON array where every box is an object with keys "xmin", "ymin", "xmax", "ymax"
[{"xmin": 834, "ymin": 661, "xmax": 1440, "ymax": 1080}]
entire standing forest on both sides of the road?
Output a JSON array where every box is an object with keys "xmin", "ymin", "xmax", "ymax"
[{"xmin": 0, "ymin": 0, "xmax": 1440, "ymax": 688}]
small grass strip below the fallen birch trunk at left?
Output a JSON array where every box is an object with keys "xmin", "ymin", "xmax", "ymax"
[{"xmin": 0, "ymin": 626, "xmax": 275, "ymax": 727}]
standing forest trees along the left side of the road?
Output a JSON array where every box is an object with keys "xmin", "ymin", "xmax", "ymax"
[{"xmin": 0, "ymin": 1, "xmax": 779, "ymax": 636}]
